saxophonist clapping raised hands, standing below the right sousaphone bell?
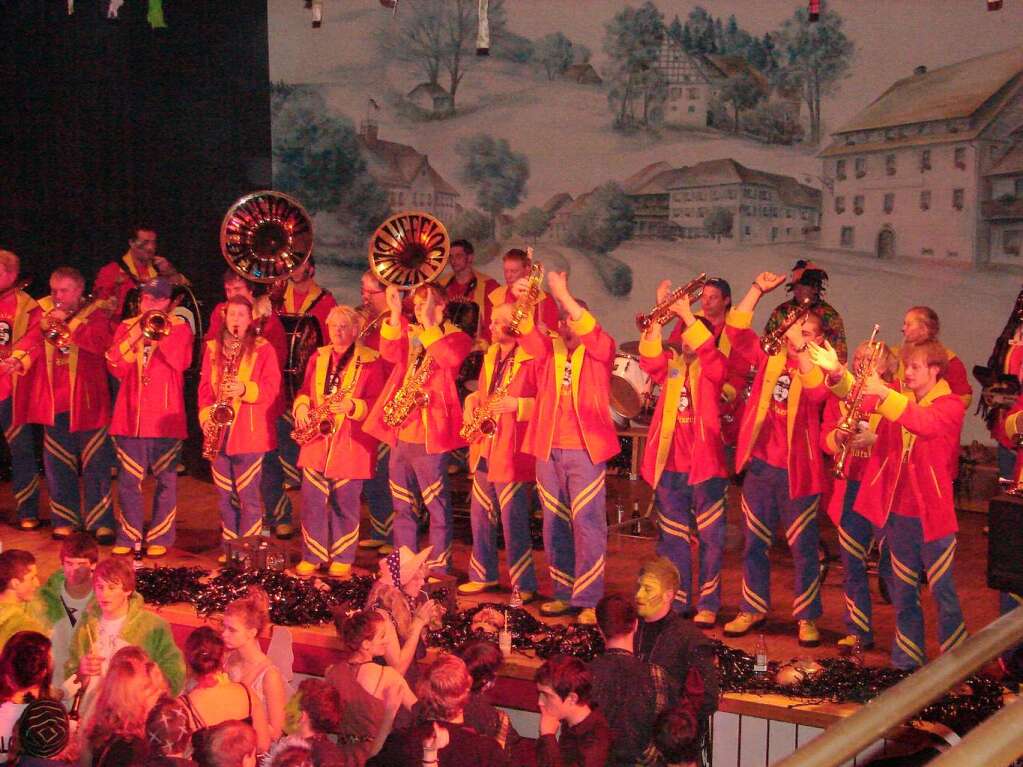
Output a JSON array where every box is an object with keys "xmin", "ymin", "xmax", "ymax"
[{"xmin": 366, "ymin": 283, "xmax": 473, "ymax": 575}]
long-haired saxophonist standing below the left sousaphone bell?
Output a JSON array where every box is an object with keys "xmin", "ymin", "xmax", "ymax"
[{"xmin": 198, "ymin": 296, "xmax": 280, "ymax": 561}]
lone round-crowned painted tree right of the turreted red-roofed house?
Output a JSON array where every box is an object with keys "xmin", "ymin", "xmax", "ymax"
[{"xmin": 456, "ymin": 133, "xmax": 529, "ymax": 233}]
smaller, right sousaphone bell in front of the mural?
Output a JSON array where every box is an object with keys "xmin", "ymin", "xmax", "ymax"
[{"xmin": 369, "ymin": 211, "xmax": 451, "ymax": 290}]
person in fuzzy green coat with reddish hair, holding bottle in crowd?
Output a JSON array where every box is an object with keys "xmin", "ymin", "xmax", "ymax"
[{"xmin": 64, "ymin": 556, "xmax": 185, "ymax": 705}]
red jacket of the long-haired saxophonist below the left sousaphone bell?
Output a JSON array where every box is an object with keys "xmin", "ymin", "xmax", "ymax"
[{"xmin": 198, "ymin": 339, "xmax": 280, "ymax": 455}]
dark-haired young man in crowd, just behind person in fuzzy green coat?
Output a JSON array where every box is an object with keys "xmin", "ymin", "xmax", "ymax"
[{"xmin": 39, "ymin": 533, "xmax": 99, "ymax": 688}]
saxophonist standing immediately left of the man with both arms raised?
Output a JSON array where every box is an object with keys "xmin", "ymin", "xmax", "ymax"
[{"xmin": 458, "ymin": 304, "xmax": 536, "ymax": 600}]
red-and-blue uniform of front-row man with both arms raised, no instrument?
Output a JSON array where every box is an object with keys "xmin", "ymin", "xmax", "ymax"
[{"xmin": 519, "ymin": 311, "xmax": 621, "ymax": 614}]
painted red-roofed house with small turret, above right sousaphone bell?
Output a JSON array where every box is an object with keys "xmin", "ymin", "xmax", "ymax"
[{"xmin": 357, "ymin": 120, "xmax": 458, "ymax": 221}]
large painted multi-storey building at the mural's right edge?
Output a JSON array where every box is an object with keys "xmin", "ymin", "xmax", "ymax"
[{"xmin": 820, "ymin": 48, "xmax": 1023, "ymax": 265}]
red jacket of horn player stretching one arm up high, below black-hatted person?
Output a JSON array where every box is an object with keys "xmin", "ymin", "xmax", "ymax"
[{"xmin": 725, "ymin": 309, "xmax": 850, "ymax": 498}]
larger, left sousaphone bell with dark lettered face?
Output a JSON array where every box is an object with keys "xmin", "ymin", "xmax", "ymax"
[{"xmin": 220, "ymin": 190, "xmax": 313, "ymax": 282}]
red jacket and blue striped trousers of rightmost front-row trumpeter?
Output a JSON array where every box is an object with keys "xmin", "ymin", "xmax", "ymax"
[{"xmin": 854, "ymin": 378, "xmax": 967, "ymax": 669}]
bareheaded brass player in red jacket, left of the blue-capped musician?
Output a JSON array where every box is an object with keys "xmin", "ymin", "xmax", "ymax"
[{"xmin": 14, "ymin": 266, "xmax": 114, "ymax": 544}]
